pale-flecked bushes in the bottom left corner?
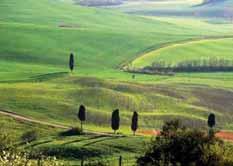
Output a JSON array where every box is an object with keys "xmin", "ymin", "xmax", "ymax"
[{"xmin": 0, "ymin": 128, "xmax": 63, "ymax": 166}]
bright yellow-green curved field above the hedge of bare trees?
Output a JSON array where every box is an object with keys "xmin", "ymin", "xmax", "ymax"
[{"xmin": 132, "ymin": 38, "xmax": 233, "ymax": 68}]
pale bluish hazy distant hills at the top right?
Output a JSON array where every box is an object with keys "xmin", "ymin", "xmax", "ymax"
[{"xmin": 112, "ymin": 0, "xmax": 233, "ymax": 22}]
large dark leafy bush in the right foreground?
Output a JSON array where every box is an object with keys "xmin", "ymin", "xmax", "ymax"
[{"xmin": 137, "ymin": 120, "xmax": 233, "ymax": 166}]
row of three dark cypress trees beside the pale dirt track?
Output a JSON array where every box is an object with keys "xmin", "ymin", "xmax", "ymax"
[{"xmin": 78, "ymin": 105, "xmax": 138, "ymax": 135}]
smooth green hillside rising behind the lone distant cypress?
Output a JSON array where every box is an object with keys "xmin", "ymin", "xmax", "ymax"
[{"xmin": 0, "ymin": 0, "xmax": 231, "ymax": 80}]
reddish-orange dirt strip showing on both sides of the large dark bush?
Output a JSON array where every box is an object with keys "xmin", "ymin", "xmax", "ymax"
[{"xmin": 139, "ymin": 130, "xmax": 233, "ymax": 141}]
